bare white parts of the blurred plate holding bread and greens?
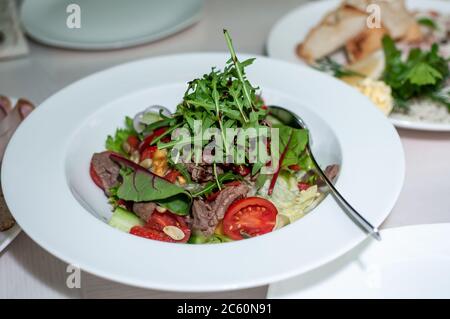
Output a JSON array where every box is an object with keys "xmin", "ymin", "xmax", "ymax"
[{"xmin": 267, "ymin": 0, "xmax": 450, "ymax": 131}]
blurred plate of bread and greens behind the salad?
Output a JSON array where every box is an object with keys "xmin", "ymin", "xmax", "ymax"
[{"xmin": 267, "ymin": 0, "xmax": 450, "ymax": 131}]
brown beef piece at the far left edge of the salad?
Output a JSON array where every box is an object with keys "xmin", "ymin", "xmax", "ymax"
[{"xmin": 91, "ymin": 151, "xmax": 120, "ymax": 195}]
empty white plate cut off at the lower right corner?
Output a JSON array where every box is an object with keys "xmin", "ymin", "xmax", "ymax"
[{"xmin": 267, "ymin": 224, "xmax": 450, "ymax": 299}]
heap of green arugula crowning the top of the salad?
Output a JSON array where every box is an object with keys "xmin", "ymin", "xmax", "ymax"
[{"xmin": 146, "ymin": 30, "xmax": 267, "ymax": 169}]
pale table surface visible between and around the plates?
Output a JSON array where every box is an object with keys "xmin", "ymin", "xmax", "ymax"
[{"xmin": 0, "ymin": 0, "xmax": 450, "ymax": 298}]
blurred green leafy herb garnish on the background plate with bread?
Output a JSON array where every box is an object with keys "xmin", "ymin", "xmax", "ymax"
[{"xmin": 382, "ymin": 36, "xmax": 450, "ymax": 109}]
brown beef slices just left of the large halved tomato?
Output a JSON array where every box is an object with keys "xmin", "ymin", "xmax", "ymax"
[{"xmin": 192, "ymin": 184, "xmax": 249, "ymax": 237}]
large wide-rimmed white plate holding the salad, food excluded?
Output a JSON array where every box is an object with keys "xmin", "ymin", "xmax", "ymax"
[{"xmin": 2, "ymin": 53, "xmax": 404, "ymax": 291}]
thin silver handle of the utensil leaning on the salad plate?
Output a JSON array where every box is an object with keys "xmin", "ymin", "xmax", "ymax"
[{"xmin": 306, "ymin": 143, "xmax": 381, "ymax": 240}]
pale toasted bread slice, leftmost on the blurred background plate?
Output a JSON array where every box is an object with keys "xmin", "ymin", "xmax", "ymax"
[{"xmin": 297, "ymin": 6, "xmax": 367, "ymax": 63}]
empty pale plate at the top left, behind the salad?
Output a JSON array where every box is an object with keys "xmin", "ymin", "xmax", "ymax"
[{"xmin": 21, "ymin": 0, "xmax": 203, "ymax": 50}]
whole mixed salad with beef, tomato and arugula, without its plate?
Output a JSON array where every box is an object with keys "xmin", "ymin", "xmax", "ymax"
[{"xmin": 90, "ymin": 31, "xmax": 338, "ymax": 244}]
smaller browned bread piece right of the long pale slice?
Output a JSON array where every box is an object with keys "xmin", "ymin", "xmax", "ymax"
[{"xmin": 345, "ymin": 27, "xmax": 387, "ymax": 63}]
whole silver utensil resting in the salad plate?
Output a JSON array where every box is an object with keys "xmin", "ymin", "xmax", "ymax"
[{"xmin": 269, "ymin": 105, "xmax": 381, "ymax": 240}]
